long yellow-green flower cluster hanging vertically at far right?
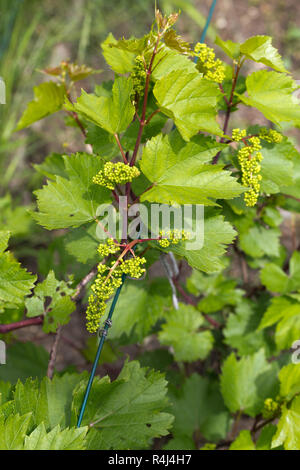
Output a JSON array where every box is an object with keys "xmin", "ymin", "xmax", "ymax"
[{"xmin": 238, "ymin": 137, "xmax": 263, "ymax": 207}]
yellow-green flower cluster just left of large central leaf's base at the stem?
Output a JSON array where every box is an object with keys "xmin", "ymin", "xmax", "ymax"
[{"xmin": 93, "ymin": 162, "xmax": 140, "ymax": 190}]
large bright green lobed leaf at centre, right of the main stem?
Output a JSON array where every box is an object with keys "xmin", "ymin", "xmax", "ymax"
[{"xmin": 141, "ymin": 131, "xmax": 243, "ymax": 205}]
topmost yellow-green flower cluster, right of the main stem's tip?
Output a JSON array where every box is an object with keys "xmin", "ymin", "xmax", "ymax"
[{"xmin": 194, "ymin": 42, "xmax": 225, "ymax": 83}]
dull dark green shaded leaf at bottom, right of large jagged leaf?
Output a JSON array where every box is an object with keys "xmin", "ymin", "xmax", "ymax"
[{"xmin": 170, "ymin": 374, "xmax": 231, "ymax": 442}]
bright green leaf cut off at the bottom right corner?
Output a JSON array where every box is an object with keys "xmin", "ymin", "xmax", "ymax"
[{"xmin": 272, "ymin": 396, "xmax": 300, "ymax": 450}]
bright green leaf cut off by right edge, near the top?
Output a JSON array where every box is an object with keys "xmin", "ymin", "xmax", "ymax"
[{"xmin": 237, "ymin": 70, "xmax": 300, "ymax": 125}]
